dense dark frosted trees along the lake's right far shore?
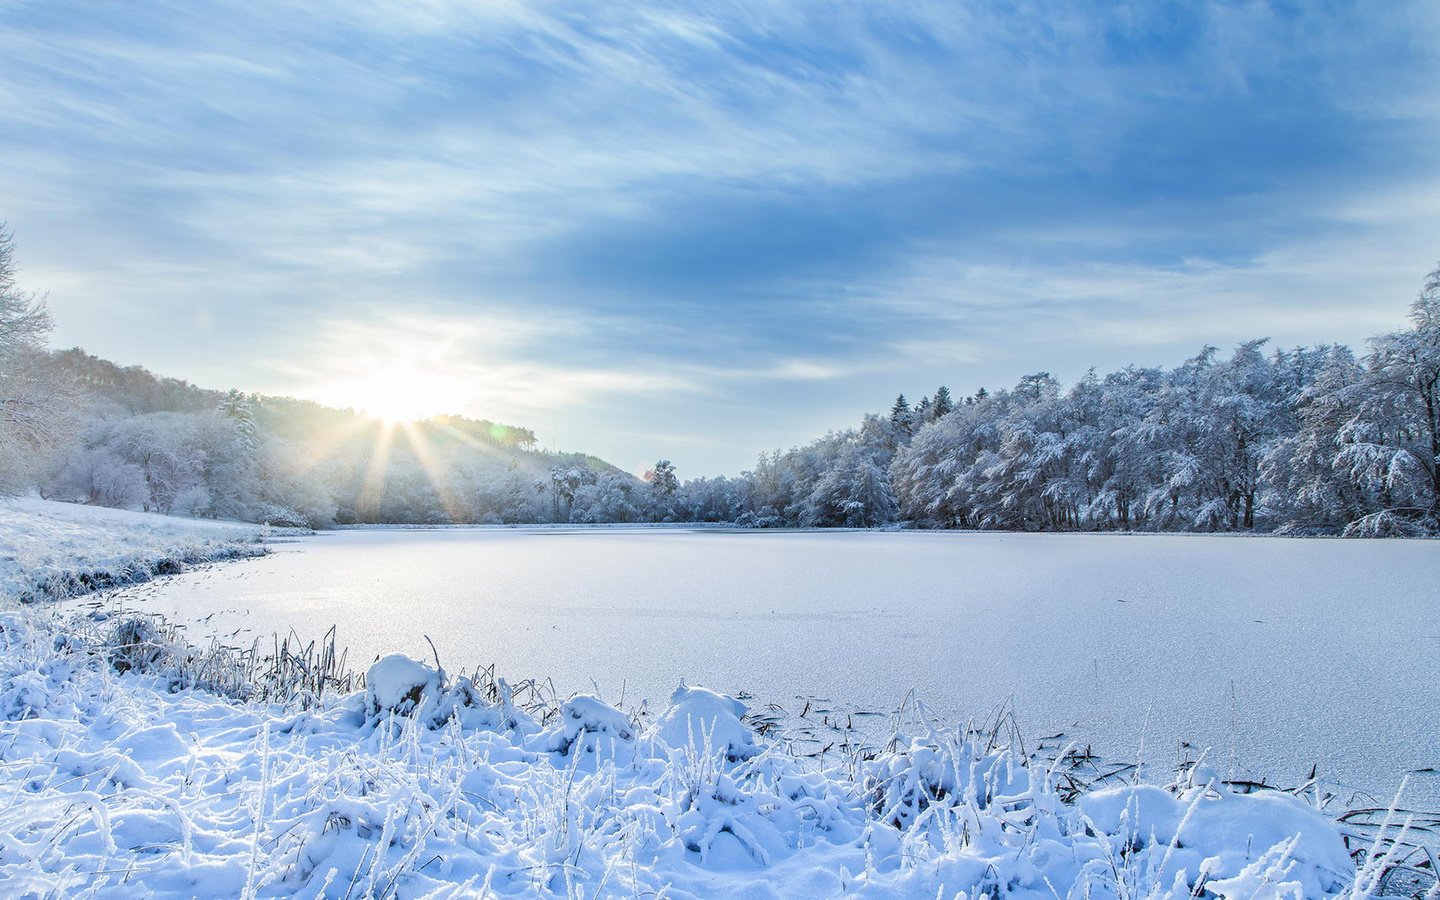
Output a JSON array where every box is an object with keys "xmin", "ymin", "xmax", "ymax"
[{"xmin": 708, "ymin": 268, "xmax": 1440, "ymax": 536}]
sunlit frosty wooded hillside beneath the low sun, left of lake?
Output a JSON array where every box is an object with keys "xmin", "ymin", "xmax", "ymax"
[{"xmin": 30, "ymin": 348, "xmax": 644, "ymax": 527}]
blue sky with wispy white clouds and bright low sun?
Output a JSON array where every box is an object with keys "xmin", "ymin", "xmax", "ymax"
[{"xmin": 0, "ymin": 0, "xmax": 1440, "ymax": 478}]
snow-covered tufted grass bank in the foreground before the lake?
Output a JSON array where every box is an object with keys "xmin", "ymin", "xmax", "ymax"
[{"xmin": 0, "ymin": 507, "xmax": 1434, "ymax": 899}]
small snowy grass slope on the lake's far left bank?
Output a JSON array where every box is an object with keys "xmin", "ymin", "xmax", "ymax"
[{"xmin": 0, "ymin": 497, "xmax": 277, "ymax": 602}]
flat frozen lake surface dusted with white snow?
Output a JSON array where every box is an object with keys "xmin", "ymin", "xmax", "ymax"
[{"xmin": 104, "ymin": 528, "xmax": 1440, "ymax": 801}]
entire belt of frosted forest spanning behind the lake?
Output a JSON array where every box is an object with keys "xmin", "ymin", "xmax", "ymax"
[{"xmin": 0, "ymin": 227, "xmax": 1440, "ymax": 536}]
